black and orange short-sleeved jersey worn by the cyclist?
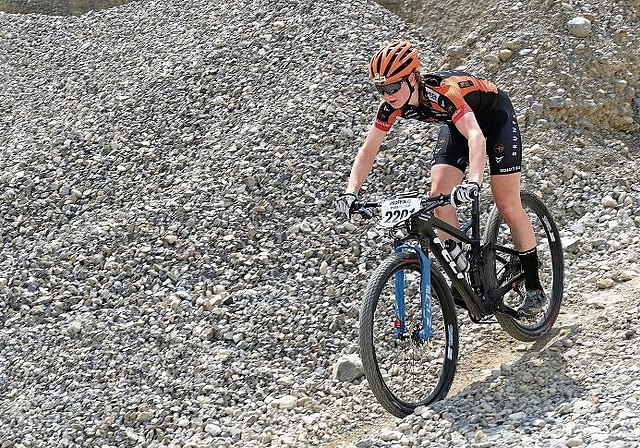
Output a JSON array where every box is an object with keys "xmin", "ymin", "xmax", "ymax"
[{"xmin": 374, "ymin": 71, "xmax": 498, "ymax": 132}]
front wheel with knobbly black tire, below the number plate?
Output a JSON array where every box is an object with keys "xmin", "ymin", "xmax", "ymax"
[{"xmin": 359, "ymin": 251, "xmax": 458, "ymax": 418}]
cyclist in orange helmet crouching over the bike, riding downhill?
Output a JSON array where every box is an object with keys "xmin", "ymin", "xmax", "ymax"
[{"xmin": 336, "ymin": 41, "xmax": 546, "ymax": 316}]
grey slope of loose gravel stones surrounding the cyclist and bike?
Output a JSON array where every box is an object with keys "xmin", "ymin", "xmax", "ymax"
[{"xmin": 0, "ymin": 0, "xmax": 640, "ymax": 447}]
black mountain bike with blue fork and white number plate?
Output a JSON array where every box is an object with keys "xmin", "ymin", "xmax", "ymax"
[{"xmin": 353, "ymin": 191, "xmax": 564, "ymax": 417}]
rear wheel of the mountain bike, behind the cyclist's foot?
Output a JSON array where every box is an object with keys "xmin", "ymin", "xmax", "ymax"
[{"xmin": 484, "ymin": 191, "xmax": 564, "ymax": 342}]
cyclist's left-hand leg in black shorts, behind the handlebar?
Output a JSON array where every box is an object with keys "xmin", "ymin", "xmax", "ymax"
[{"xmin": 431, "ymin": 125, "xmax": 469, "ymax": 234}]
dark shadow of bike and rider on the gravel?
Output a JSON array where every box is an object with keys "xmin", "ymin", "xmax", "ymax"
[{"xmin": 423, "ymin": 323, "xmax": 586, "ymax": 436}]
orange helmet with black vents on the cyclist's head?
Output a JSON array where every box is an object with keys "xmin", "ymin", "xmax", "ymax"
[{"xmin": 369, "ymin": 40, "xmax": 420, "ymax": 85}]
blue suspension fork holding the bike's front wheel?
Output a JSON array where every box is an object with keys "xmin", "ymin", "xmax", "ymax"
[{"xmin": 394, "ymin": 244, "xmax": 433, "ymax": 341}]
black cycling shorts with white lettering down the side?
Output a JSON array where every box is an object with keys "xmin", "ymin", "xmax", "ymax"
[{"xmin": 433, "ymin": 91, "xmax": 522, "ymax": 176}]
